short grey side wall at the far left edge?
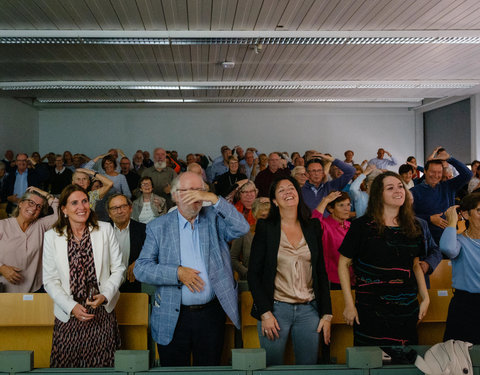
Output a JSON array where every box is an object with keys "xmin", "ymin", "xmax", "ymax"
[{"xmin": 0, "ymin": 98, "xmax": 38, "ymax": 159}]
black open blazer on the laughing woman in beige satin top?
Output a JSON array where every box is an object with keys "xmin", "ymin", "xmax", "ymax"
[{"xmin": 247, "ymin": 219, "xmax": 332, "ymax": 320}]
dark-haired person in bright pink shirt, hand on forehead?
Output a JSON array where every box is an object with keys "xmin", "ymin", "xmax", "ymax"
[{"xmin": 312, "ymin": 191, "xmax": 353, "ymax": 290}]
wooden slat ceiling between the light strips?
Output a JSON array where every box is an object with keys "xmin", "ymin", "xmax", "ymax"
[{"xmin": 0, "ymin": 0, "xmax": 480, "ymax": 106}]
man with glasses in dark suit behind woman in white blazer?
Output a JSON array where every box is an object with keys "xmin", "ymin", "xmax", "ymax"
[{"xmin": 107, "ymin": 193, "xmax": 146, "ymax": 293}]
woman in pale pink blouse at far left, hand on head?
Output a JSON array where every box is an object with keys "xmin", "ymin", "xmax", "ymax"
[{"xmin": 0, "ymin": 186, "xmax": 58, "ymax": 293}]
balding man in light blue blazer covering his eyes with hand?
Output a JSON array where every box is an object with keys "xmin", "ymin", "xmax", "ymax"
[{"xmin": 134, "ymin": 172, "xmax": 250, "ymax": 366}]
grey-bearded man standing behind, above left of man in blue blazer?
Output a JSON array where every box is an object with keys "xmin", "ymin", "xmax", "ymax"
[{"xmin": 142, "ymin": 147, "xmax": 177, "ymax": 207}]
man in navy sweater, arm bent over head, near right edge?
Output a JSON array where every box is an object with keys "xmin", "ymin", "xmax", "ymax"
[{"xmin": 410, "ymin": 147, "xmax": 472, "ymax": 247}]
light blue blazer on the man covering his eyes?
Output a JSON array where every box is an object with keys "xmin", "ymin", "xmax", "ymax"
[{"xmin": 133, "ymin": 197, "xmax": 250, "ymax": 345}]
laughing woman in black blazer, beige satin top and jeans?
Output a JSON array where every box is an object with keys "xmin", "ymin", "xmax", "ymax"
[{"xmin": 247, "ymin": 177, "xmax": 332, "ymax": 366}]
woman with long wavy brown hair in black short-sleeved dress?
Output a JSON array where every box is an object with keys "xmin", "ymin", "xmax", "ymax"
[{"xmin": 338, "ymin": 172, "xmax": 430, "ymax": 346}]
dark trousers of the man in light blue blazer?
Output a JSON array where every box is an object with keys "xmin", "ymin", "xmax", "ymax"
[{"xmin": 157, "ymin": 299, "xmax": 225, "ymax": 366}]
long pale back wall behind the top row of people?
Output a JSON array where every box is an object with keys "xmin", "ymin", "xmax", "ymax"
[{"xmin": 39, "ymin": 105, "xmax": 415, "ymax": 162}]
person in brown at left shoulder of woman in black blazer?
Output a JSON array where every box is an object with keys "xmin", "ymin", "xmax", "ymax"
[{"xmin": 230, "ymin": 197, "xmax": 270, "ymax": 280}]
